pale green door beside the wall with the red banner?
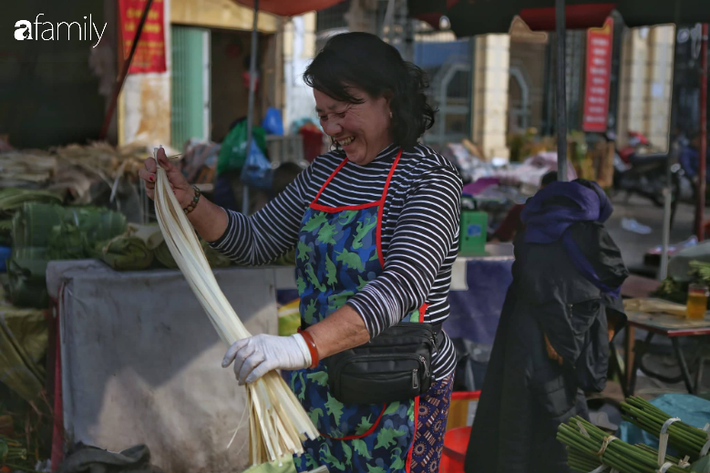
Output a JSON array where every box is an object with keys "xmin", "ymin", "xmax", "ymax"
[{"xmin": 171, "ymin": 26, "xmax": 210, "ymax": 150}]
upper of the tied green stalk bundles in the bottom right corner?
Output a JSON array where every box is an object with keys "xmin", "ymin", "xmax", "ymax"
[{"xmin": 621, "ymin": 396, "xmax": 710, "ymax": 461}]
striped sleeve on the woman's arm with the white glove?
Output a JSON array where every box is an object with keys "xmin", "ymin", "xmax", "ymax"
[{"xmin": 348, "ymin": 166, "xmax": 462, "ymax": 337}]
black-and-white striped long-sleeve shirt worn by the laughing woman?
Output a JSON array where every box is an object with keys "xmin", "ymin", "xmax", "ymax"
[{"xmin": 211, "ymin": 141, "xmax": 462, "ymax": 380}]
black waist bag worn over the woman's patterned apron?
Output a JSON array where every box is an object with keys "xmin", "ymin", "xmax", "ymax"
[{"xmin": 323, "ymin": 323, "xmax": 443, "ymax": 404}]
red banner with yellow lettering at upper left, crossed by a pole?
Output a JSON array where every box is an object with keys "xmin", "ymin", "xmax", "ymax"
[{"xmin": 118, "ymin": 0, "xmax": 167, "ymax": 74}]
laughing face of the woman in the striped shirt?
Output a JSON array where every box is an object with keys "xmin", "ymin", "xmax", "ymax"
[{"xmin": 313, "ymin": 88, "xmax": 392, "ymax": 166}]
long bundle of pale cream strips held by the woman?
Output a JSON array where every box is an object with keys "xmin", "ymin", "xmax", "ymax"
[{"xmin": 155, "ymin": 148, "xmax": 319, "ymax": 465}]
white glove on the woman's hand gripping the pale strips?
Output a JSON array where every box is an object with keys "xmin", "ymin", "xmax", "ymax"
[{"xmin": 222, "ymin": 333, "xmax": 312, "ymax": 386}]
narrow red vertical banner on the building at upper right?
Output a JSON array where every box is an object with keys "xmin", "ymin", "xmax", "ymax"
[{"xmin": 582, "ymin": 18, "xmax": 614, "ymax": 133}]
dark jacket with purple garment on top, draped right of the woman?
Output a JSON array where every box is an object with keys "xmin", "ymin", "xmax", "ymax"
[{"xmin": 465, "ymin": 180, "xmax": 628, "ymax": 473}]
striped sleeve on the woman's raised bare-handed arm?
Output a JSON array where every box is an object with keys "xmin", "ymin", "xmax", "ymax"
[{"xmin": 210, "ymin": 167, "xmax": 312, "ymax": 266}]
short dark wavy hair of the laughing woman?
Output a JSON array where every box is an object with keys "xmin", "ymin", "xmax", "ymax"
[{"xmin": 303, "ymin": 33, "xmax": 436, "ymax": 149}]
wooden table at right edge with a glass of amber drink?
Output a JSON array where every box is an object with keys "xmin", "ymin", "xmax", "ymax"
[{"xmin": 626, "ymin": 312, "xmax": 710, "ymax": 396}]
